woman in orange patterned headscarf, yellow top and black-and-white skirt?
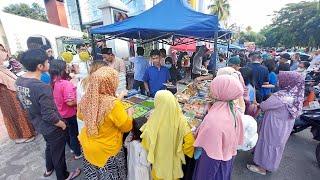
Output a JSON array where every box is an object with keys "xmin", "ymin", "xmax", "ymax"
[{"xmin": 78, "ymin": 67, "xmax": 133, "ymax": 180}]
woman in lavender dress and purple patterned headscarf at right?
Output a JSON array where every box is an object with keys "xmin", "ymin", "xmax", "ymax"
[{"xmin": 247, "ymin": 71, "xmax": 305, "ymax": 175}]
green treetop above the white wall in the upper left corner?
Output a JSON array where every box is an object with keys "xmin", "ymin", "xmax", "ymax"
[{"xmin": 3, "ymin": 3, "xmax": 48, "ymax": 22}]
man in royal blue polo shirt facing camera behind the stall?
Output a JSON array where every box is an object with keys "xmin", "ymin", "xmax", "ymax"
[{"xmin": 143, "ymin": 49, "xmax": 170, "ymax": 97}]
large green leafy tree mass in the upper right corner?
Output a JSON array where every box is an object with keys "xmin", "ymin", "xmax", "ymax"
[{"xmin": 260, "ymin": 1, "xmax": 320, "ymax": 47}]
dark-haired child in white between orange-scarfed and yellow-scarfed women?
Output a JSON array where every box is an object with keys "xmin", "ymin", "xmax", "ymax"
[{"xmin": 125, "ymin": 117, "xmax": 151, "ymax": 180}]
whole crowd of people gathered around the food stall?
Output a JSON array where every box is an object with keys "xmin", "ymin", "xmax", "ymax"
[{"xmin": 0, "ymin": 38, "xmax": 320, "ymax": 180}]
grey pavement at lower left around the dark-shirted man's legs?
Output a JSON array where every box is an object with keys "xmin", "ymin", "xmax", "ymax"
[{"xmin": 0, "ymin": 135, "xmax": 82, "ymax": 180}]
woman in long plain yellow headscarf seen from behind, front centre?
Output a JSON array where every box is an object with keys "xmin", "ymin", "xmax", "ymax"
[{"xmin": 141, "ymin": 90, "xmax": 194, "ymax": 179}]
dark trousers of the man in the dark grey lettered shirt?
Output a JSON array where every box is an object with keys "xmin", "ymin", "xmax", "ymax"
[{"xmin": 43, "ymin": 128, "xmax": 69, "ymax": 180}]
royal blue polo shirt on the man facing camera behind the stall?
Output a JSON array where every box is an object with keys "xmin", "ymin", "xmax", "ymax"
[{"xmin": 143, "ymin": 66, "xmax": 170, "ymax": 97}]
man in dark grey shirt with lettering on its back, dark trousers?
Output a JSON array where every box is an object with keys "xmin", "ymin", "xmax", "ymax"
[{"xmin": 16, "ymin": 49, "xmax": 81, "ymax": 180}]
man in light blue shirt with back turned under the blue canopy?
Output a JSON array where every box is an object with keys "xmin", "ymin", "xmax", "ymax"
[{"xmin": 130, "ymin": 47, "xmax": 149, "ymax": 94}]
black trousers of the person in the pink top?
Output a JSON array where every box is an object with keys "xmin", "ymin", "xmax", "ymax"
[{"xmin": 65, "ymin": 116, "xmax": 81, "ymax": 156}]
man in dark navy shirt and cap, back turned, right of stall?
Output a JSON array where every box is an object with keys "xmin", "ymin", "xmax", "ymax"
[{"xmin": 247, "ymin": 52, "xmax": 269, "ymax": 103}]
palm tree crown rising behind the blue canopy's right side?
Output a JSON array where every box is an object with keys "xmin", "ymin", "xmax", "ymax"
[{"xmin": 208, "ymin": 0, "xmax": 230, "ymax": 21}]
